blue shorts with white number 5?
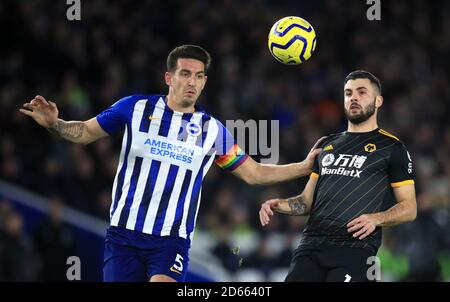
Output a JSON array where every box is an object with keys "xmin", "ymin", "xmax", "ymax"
[{"xmin": 103, "ymin": 227, "xmax": 190, "ymax": 282}]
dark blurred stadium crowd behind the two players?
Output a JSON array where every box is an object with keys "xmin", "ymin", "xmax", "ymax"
[{"xmin": 0, "ymin": 0, "xmax": 450, "ymax": 281}]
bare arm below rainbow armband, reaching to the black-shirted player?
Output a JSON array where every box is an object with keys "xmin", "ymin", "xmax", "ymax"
[{"xmin": 233, "ymin": 137, "xmax": 326, "ymax": 185}]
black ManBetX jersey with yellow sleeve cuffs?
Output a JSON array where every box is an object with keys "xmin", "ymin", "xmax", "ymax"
[{"xmin": 300, "ymin": 129, "xmax": 414, "ymax": 253}]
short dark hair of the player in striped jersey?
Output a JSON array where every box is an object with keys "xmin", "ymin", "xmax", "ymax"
[{"xmin": 167, "ymin": 44, "xmax": 211, "ymax": 72}]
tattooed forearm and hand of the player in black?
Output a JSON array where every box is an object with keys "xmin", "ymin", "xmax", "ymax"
[{"xmin": 259, "ymin": 176, "xmax": 317, "ymax": 226}]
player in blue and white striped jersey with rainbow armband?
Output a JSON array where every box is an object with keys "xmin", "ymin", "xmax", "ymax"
[{"xmin": 20, "ymin": 45, "xmax": 320, "ymax": 281}]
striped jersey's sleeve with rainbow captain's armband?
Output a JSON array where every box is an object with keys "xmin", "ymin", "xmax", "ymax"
[{"xmin": 213, "ymin": 121, "xmax": 248, "ymax": 171}]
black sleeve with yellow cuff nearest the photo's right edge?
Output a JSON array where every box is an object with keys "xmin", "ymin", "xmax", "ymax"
[{"xmin": 388, "ymin": 142, "xmax": 414, "ymax": 188}]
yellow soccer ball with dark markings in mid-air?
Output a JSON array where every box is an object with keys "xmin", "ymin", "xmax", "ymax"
[{"xmin": 268, "ymin": 16, "xmax": 316, "ymax": 65}]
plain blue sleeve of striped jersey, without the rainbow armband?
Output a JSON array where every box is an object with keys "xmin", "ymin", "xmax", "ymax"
[{"xmin": 96, "ymin": 96, "xmax": 133, "ymax": 135}]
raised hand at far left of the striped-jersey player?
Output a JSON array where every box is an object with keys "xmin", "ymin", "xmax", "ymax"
[{"xmin": 19, "ymin": 95, "xmax": 58, "ymax": 128}]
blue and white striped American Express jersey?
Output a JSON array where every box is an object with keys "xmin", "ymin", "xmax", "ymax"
[{"xmin": 97, "ymin": 95, "xmax": 247, "ymax": 239}]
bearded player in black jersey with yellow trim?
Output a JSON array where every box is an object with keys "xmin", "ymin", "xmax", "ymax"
[{"xmin": 259, "ymin": 71, "xmax": 417, "ymax": 281}]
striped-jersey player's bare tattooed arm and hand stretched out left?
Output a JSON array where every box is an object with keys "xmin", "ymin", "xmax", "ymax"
[{"xmin": 20, "ymin": 95, "xmax": 108, "ymax": 144}]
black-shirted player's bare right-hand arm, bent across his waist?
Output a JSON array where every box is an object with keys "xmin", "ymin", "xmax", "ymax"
[{"xmin": 347, "ymin": 185, "xmax": 417, "ymax": 239}]
